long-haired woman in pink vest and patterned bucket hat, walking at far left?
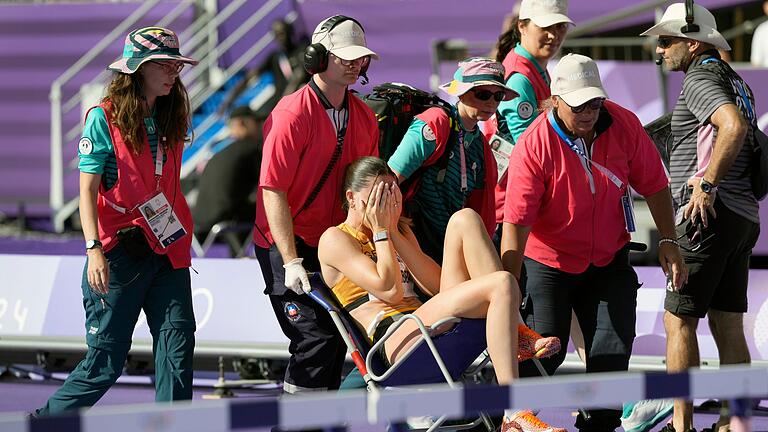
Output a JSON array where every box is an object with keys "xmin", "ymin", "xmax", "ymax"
[{"xmin": 35, "ymin": 27, "xmax": 197, "ymax": 416}]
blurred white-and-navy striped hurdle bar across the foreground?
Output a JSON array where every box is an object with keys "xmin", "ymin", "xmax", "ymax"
[{"xmin": 0, "ymin": 365, "xmax": 768, "ymax": 432}]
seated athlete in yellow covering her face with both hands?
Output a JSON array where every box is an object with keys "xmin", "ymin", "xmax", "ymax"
[{"xmin": 318, "ymin": 157, "xmax": 564, "ymax": 431}]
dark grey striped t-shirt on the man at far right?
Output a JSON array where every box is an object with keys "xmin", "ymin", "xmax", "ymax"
[{"xmin": 669, "ymin": 53, "xmax": 759, "ymax": 223}]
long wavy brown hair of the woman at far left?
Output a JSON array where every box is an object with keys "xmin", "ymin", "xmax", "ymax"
[{"xmin": 102, "ymin": 66, "xmax": 190, "ymax": 154}]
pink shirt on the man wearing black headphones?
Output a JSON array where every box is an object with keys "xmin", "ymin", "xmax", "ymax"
[{"xmin": 253, "ymin": 85, "xmax": 379, "ymax": 248}]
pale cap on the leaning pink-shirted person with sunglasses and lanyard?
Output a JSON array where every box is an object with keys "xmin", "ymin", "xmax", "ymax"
[{"xmin": 550, "ymin": 54, "xmax": 608, "ymax": 107}]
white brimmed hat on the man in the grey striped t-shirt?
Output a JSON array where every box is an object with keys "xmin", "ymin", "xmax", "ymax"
[{"xmin": 640, "ymin": 3, "xmax": 731, "ymax": 51}]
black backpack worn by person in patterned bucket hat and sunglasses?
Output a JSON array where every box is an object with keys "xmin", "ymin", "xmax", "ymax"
[{"xmin": 362, "ymin": 83, "xmax": 453, "ymax": 160}]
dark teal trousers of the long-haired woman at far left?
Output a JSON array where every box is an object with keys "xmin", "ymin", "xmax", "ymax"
[{"xmin": 36, "ymin": 244, "xmax": 195, "ymax": 416}]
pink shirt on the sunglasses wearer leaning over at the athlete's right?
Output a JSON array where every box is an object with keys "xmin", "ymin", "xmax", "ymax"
[{"xmin": 504, "ymin": 101, "xmax": 669, "ymax": 273}]
